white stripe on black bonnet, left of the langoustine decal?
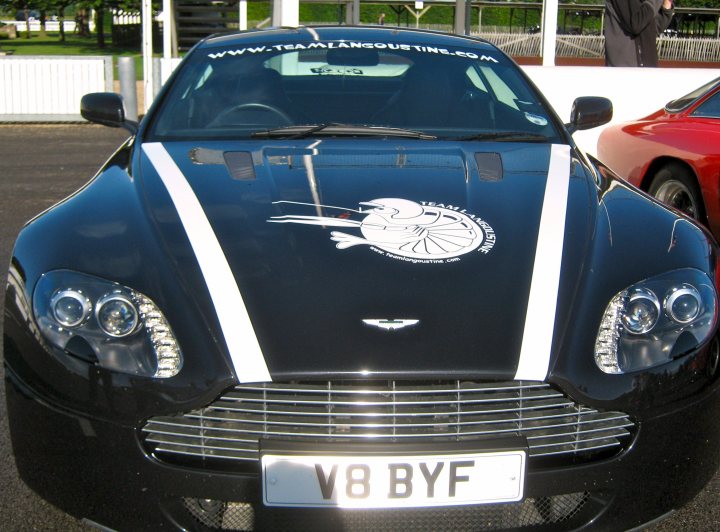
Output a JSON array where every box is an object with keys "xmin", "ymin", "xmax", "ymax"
[{"xmin": 143, "ymin": 142, "xmax": 272, "ymax": 382}]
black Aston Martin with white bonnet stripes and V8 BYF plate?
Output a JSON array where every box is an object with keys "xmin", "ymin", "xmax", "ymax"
[{"xmin": 4, "ymin": 27, "xmax": 720, "ymax": 530}]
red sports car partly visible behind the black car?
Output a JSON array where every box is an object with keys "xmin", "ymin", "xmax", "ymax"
[{"xmin": 598, "ymin": 78, "xmax": 720, "ymax": 238}]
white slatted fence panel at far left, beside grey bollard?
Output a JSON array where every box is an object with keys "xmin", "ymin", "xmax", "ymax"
[{"xmin": 0, "ymin": 56, "xmax": 113, "ymax": 122}]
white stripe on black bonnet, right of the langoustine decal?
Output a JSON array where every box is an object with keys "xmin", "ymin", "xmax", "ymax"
[{"xmin": 515, "ymin": 144, "xmax": 570, "ymax": 381}]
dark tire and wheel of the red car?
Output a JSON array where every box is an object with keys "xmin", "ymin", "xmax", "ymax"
[{"xmin": 648, "ymin": 163, "xmax": 707, "ymax": 224}]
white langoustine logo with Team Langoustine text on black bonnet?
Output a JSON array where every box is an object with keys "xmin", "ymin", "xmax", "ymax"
[{"xmin": 268, "ymin": 198, "xmax": 495, "ymax": 264}]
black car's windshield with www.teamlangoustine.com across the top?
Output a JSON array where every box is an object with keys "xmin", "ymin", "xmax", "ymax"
[{"xmin": 149, "ymin": 42, "xmax": 558, "ymax": 141}]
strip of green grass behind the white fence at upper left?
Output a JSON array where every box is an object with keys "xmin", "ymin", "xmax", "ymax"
[{"xmin": 0, "ymin": 32, "xmax": 150, "ymax": 79}]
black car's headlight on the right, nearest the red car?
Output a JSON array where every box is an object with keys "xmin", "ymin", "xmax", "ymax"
[{"xmin": 595, "ymin": 268, "xmax": 717, "ymax": 373}]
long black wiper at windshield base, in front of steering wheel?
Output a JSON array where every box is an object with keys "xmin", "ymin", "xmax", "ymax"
[{"xmin": 251, "ymin": 122, "xmax": 437, "ymax": 140}]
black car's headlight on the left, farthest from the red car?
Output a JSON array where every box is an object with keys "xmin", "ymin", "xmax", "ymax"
[{"xmin": 33, "ymin": 270, "xmax": 183, "ymax": 378}]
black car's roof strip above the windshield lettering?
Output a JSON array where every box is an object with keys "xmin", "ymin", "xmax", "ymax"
[{"xmin": 199, "ymin": 26, "xmax": 499, "ymax": 52}]
